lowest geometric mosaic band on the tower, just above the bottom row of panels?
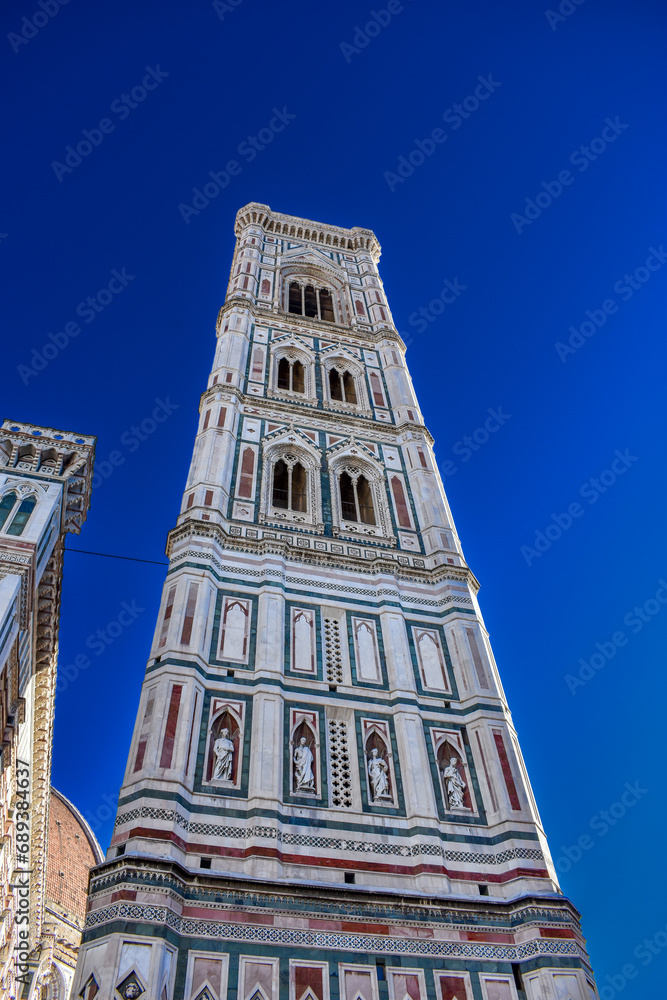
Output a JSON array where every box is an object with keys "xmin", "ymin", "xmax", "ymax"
[{"xmin": 86, "ymin": 902, "xmax": 585, "ymax": 962}]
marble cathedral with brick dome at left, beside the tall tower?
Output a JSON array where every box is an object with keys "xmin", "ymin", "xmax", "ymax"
[{"xmin": 0, "ymin": 420, "xmax": 100, "ymax": 1000}]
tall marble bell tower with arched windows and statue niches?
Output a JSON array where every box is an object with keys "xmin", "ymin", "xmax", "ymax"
[{"xmin": 73, "ymin": 203, "xmax": 597, "ymax": 1000}]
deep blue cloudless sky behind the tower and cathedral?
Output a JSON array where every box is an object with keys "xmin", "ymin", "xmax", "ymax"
[{"xmin": 0, "ymin": 0, "xmax": 667, "ymax": 1000}]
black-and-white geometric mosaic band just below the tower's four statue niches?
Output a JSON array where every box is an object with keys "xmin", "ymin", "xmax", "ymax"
[{"xmin": 116, "ymin": 808, "xmax": 544, "ymax": 865}]
